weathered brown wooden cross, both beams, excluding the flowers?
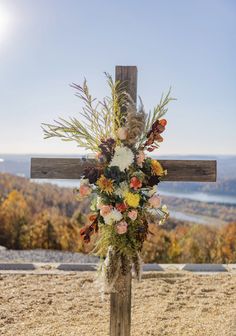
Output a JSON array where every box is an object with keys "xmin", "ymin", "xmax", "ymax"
[{"xmin": 31, "ymin": 66, "xmax": 216, "ymax": 336}]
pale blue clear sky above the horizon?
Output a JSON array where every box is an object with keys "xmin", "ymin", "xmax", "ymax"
[{"xmin": 0, "ymin": 0, "xmax": 236, "ymax": 155}]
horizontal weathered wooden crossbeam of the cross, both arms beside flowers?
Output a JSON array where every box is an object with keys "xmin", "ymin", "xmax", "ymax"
[{"xmin": 31, "ymin": 158, "xmax": 216, "ymax": 182}]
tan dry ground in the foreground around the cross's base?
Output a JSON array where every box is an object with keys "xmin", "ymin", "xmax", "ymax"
[{"xmin": 0, "ymin": 272, "xmax": 236, "ymax": 336}]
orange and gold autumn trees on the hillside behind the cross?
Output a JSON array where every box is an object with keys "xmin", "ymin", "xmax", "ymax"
[{"xmin": 0, "ymin": 174, "xmax": 236, "ymax": 263}]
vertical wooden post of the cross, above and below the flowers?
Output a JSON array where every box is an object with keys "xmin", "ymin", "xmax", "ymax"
[{"xmin": 110, "ymin": 66, "xmax": 137, "ymax": 336}]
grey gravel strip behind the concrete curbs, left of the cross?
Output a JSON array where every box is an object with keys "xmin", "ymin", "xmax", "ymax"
[{"xmin": 0, "ymin": 249, "xmax": 99, "ymax": 264}]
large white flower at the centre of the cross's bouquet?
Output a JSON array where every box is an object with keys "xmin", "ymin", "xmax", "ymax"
[{"xmin": 110, "ymin": 146, "xmax": 134, "ymax": 171}]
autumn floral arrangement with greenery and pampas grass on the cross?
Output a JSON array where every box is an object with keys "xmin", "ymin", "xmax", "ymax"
[{"xmin": 43, "ymin": 74, "xmax": 173, "ymax": 288}]
